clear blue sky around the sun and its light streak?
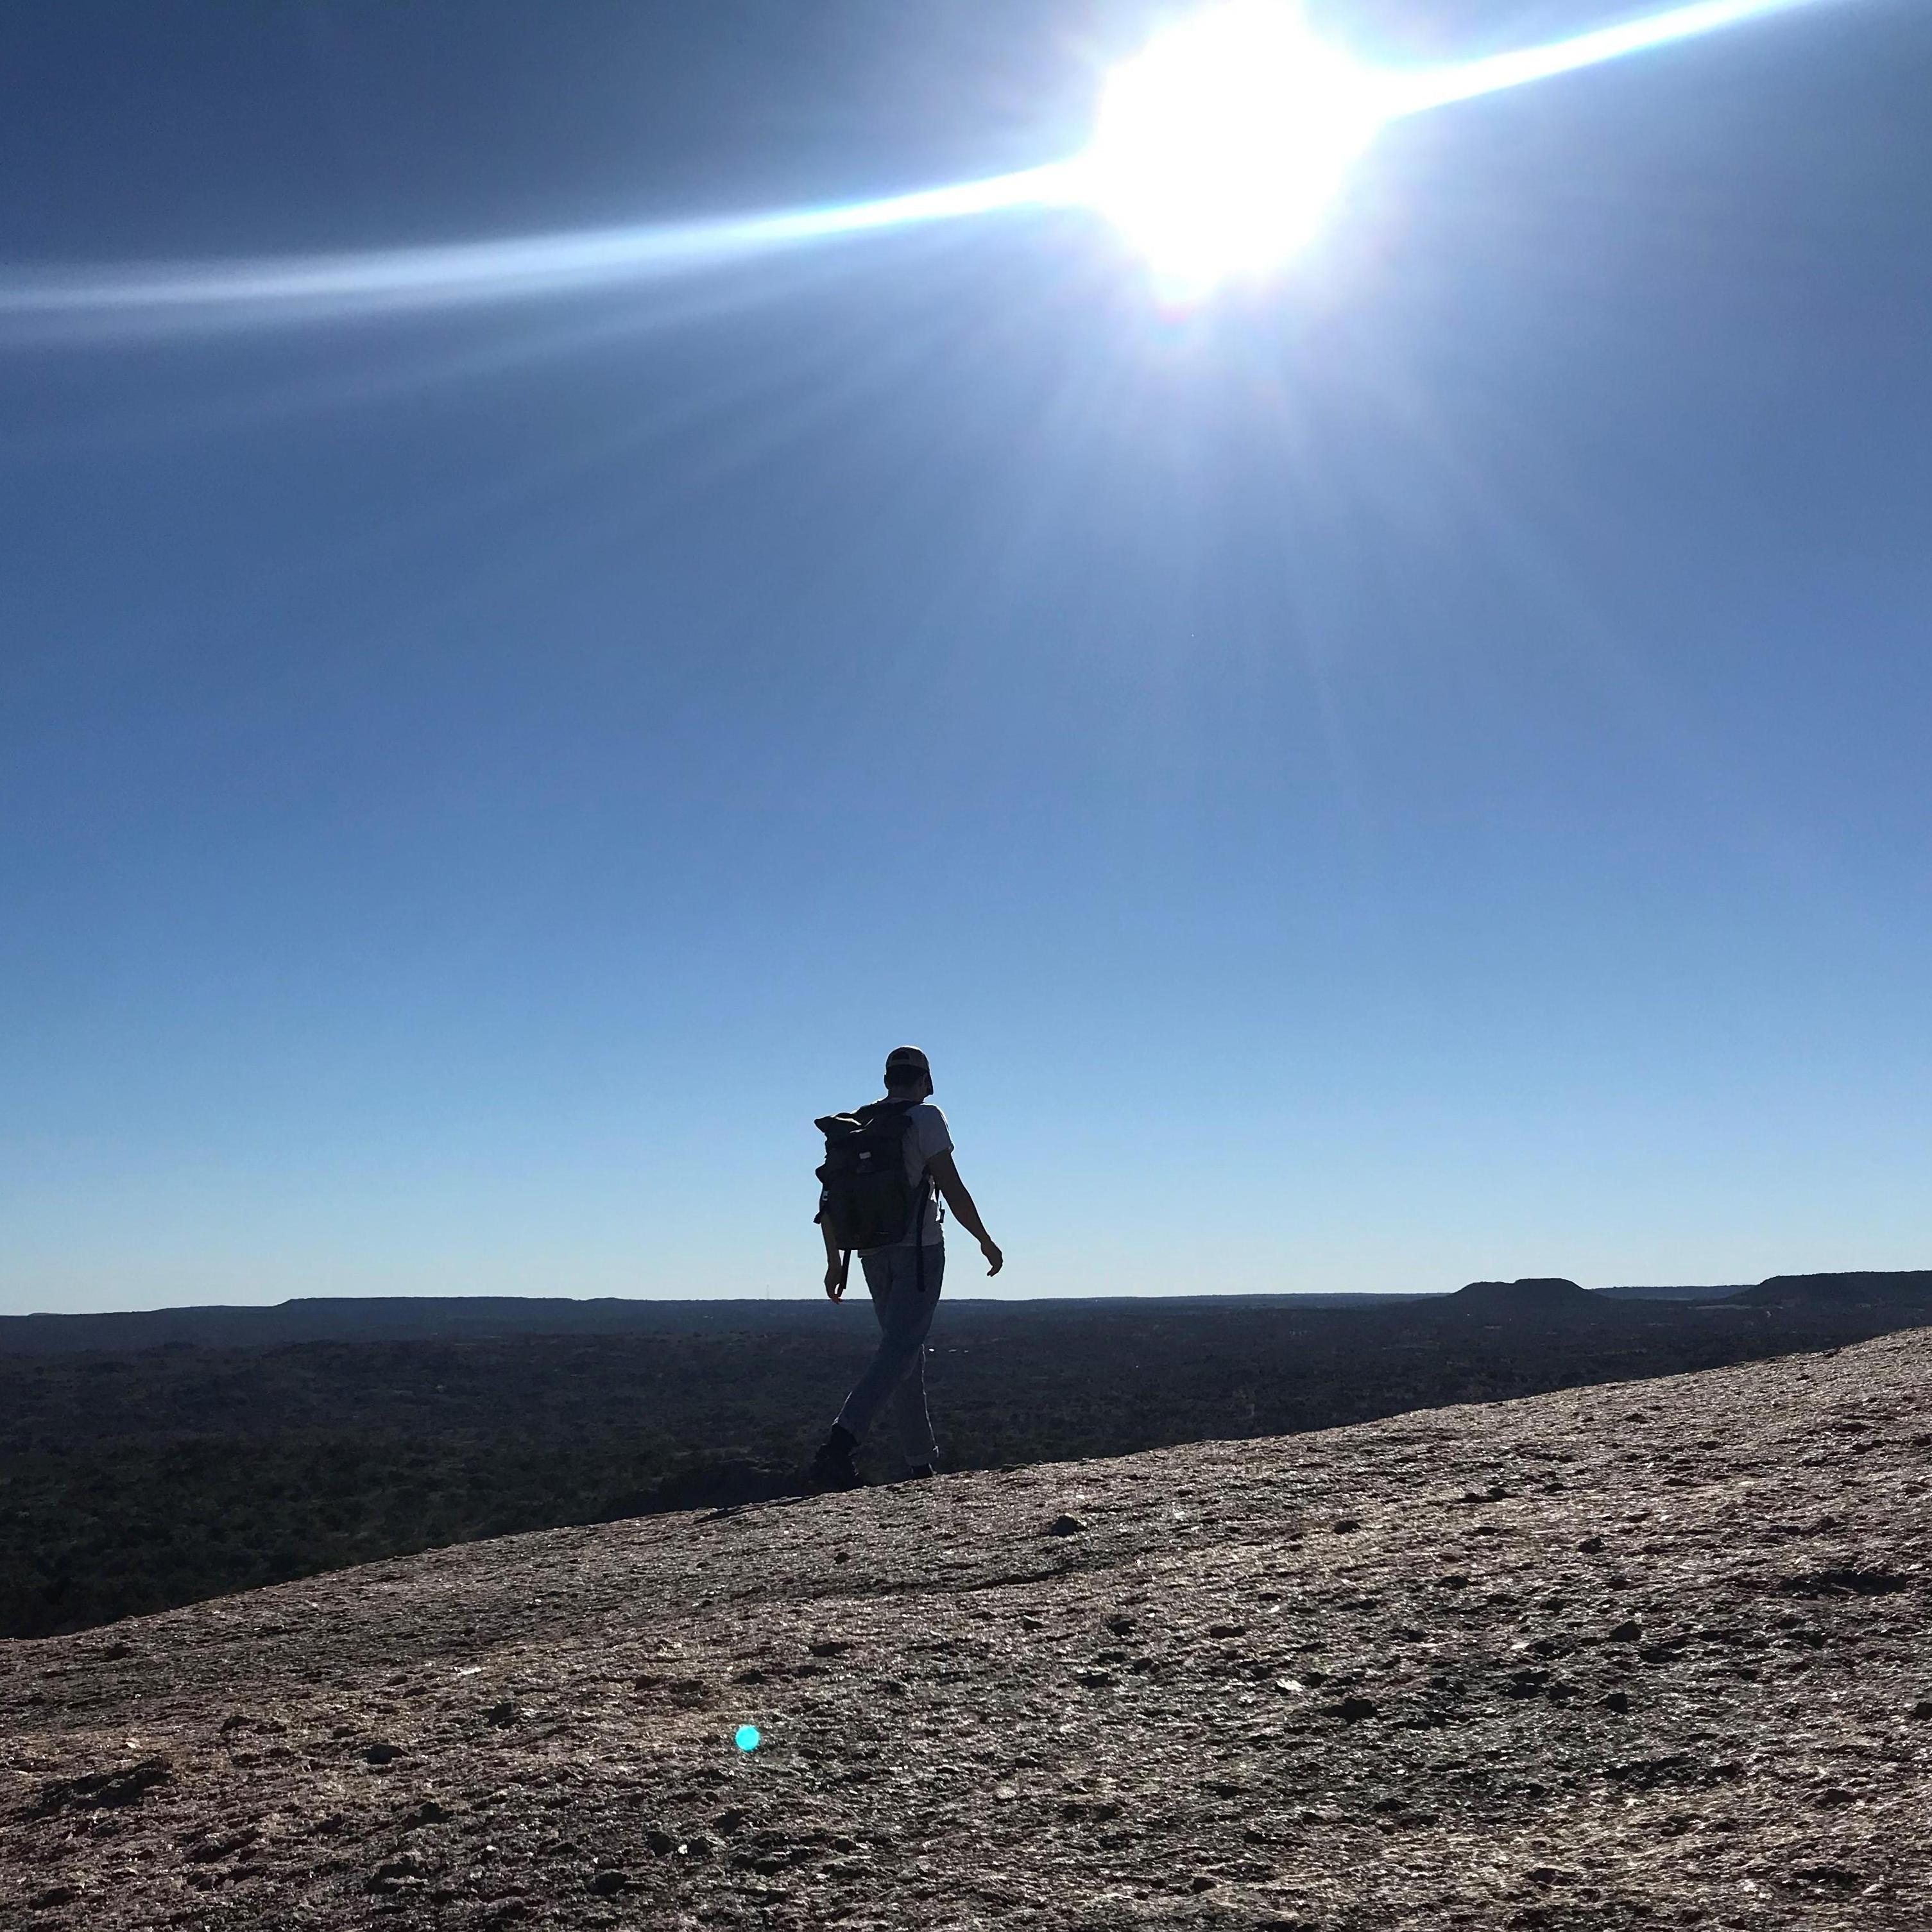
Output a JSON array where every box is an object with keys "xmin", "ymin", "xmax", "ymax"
[{"xmin": 0, "ymin": 0, "xmax": 1932, "ymax": 1312}]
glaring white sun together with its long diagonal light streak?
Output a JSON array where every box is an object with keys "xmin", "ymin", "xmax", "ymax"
[{"xmin": 0, "ymin": 0, "xmax": 1854, "ymax": 344}]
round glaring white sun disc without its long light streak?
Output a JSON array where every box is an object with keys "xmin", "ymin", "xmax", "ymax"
[{"xmin": 1074, "ymin": 0, "xmax": 1393, "ymax": 300}]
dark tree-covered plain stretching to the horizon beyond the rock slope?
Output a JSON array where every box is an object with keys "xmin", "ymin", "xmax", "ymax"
[{"xmin": 0, "ymin": 1275, "xmax": 1932, "ymax": 1636}]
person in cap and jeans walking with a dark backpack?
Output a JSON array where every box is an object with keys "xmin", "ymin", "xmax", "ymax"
[{"xmin": 812, "ymin": 1047, "xmax": 1005, "ymax": 1489}]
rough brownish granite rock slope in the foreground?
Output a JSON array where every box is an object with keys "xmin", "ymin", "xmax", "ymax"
[{"xmin": 0, "ymin": 1329, "xmax": 1932, "ymax": 1932}]
